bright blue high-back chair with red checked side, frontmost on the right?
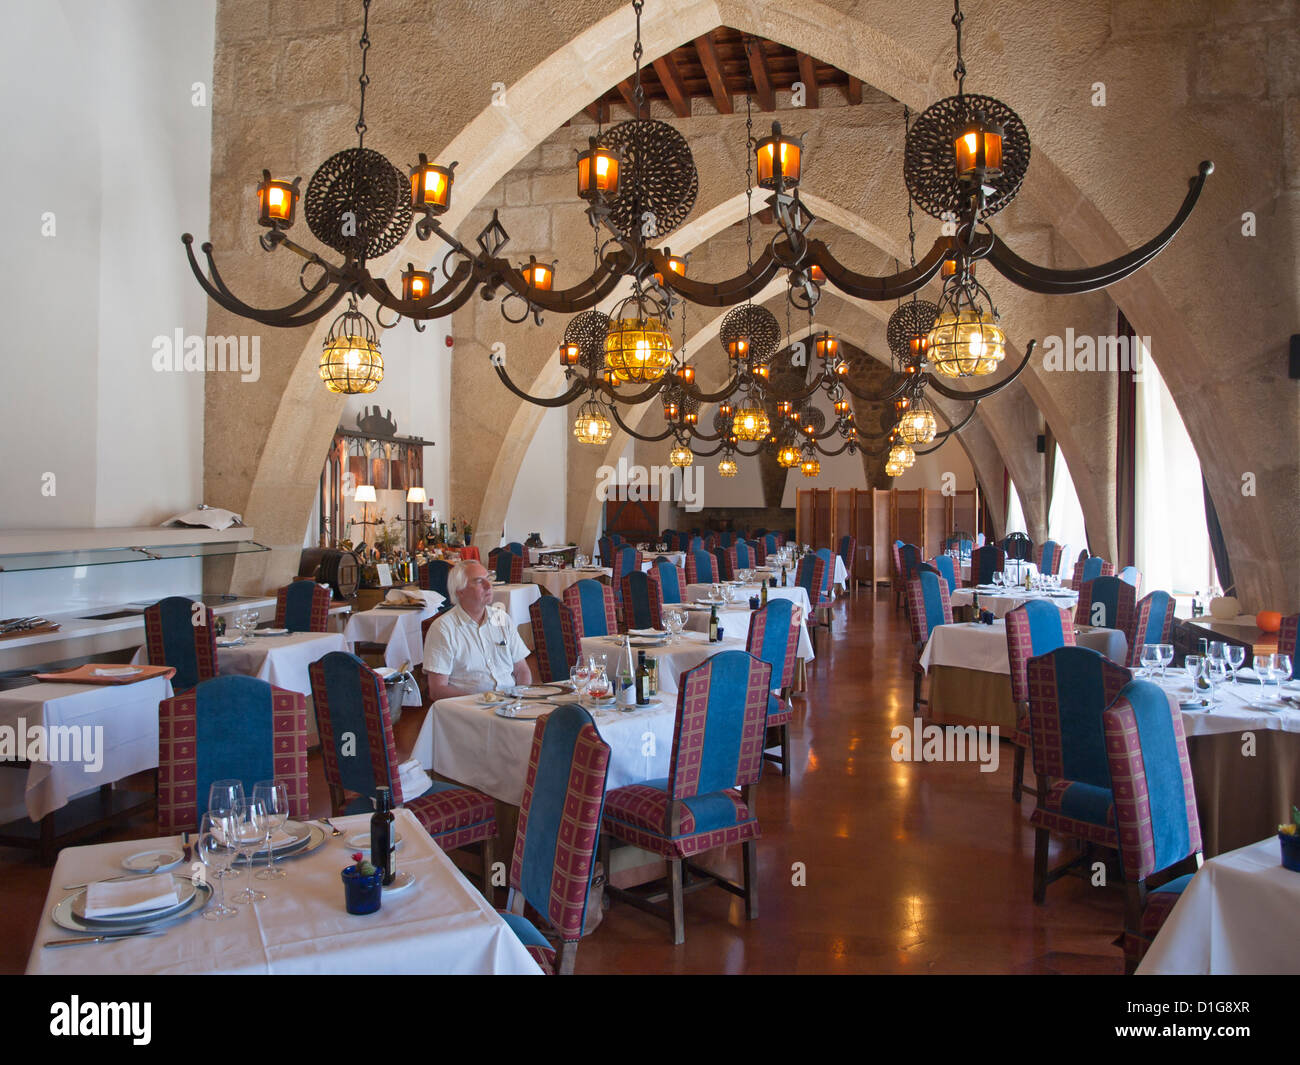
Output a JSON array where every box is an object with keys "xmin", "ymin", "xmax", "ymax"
[{"xmin": 1101, "ymin": 680, "xmax": 1201, "ymax": 974}]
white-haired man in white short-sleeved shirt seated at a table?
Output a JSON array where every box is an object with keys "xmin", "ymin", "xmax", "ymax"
[{"xmin": 424, "ymin": 560, "xmax": 533, "ymax": 702}]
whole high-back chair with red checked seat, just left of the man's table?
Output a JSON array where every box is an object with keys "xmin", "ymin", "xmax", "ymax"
[{"xmin": 308, "ymin": 651, "xmax": 497, "ymax": 897}]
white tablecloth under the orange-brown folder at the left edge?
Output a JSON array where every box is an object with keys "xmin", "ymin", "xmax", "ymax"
[{"xmin": 0, "ymin": 676, "xmax": 172, "ymax": 822}]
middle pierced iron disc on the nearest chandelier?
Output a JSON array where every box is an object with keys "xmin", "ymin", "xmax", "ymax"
[{"xmin": 597, "ymin": 118, "xmax": 699, "ymax": 243}]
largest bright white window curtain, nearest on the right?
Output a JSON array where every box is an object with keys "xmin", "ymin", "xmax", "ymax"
[{"xmin": 1134, "ymin": 352, "xmax": 1214, "ymax": 594}]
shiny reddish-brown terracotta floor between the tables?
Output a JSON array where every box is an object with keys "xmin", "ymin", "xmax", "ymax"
[{"xmin": 0, "ymin": 590, "xmax": 1123, "ymax": 974}]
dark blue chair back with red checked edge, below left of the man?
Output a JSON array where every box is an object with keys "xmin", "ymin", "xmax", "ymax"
[{"xmin": 309, "ymin": 650, "xmax": 395, "ymax": 814}]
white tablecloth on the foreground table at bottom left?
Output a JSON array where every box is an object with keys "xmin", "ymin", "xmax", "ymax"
[{"xmin": 27, "ymin": 810, "xmax": 540, "ymax": 977}]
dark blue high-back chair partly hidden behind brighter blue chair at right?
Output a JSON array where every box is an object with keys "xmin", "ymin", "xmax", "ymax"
[{"xmin": 1026, "ymin": 648, "xmax": 1132, "ymax": 905}]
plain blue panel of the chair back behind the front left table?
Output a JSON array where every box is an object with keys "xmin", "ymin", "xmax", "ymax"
[{"xmin": 194, "ymin": 681, "xmax": 276, "ymax": 818}]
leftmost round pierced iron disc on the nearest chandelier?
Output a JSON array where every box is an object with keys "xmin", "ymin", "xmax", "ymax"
[{"xmin": 303, "ymin": 148, "xmax": 411, "ymax": 259}]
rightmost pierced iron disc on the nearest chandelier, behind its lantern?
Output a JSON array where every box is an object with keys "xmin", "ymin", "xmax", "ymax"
[{"xmin": 902, "ymin": 94, "xmax": 1030, "ymax": 220}]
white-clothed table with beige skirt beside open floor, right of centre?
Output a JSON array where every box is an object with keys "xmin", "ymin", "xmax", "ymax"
[{"xmin": 920, "ymin": 616, "xmax": 1128, "ymax": 735}]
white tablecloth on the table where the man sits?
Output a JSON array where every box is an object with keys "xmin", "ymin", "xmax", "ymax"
[{"xmin": 411, "ymin": 693, "xmax": 677, "ymax": 806}]
